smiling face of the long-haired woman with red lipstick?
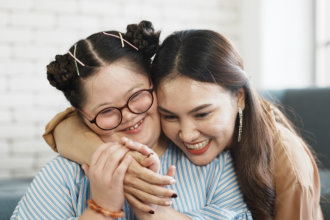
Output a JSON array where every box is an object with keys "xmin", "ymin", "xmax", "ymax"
[{"xmin": 157, "ymin": 76, "xmax": 245, "ymax": 165}]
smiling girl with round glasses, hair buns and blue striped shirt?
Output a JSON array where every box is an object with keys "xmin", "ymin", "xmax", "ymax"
[{"xmin": 13, "ymin": 22, "xmax": 251, "ymax": 219}]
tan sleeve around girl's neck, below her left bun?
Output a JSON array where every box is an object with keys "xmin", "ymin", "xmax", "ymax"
[{"xmin": 43, "ymin": 108, "xmax": 103, "ymax": 164}]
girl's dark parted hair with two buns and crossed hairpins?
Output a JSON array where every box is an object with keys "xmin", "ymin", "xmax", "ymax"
[{"xmin": 47, "ymin": 21, "xmax": 160, "ymax": 109}]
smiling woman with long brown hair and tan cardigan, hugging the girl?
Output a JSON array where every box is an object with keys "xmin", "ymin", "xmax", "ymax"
[{"xmin": 48, "ymin": 30, "xmax": 322, "ymax": 219}]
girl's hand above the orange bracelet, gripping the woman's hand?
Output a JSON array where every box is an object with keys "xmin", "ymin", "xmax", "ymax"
[{"xmin": 82, "ymin": 143, "xmax": 132, "ymax": 211}]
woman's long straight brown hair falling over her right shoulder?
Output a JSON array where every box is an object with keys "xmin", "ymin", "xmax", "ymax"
[{"xmin": 151, "ymin": 30, "xmax": 276, "ymax": 219}]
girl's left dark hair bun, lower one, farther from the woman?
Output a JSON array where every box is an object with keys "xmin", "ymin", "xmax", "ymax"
[{"xmin": 47, "ymin": 54, "xmax": 78, "ymax": 92}]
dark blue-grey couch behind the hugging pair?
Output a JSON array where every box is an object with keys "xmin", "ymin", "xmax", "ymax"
[{"xmin": 0, "ymin": 88, "xmax": 330, "ymax": 220}]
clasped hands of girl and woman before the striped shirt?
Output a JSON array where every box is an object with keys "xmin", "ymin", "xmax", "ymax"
[{"xmin": 82, "ymin": 138, "xmax": 177, "ymax": 213}]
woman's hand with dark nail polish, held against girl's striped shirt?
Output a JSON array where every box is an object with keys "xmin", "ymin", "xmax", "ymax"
[{"xmin": 122, "ymin": 138, "xmax": 177, "ymax": 213}]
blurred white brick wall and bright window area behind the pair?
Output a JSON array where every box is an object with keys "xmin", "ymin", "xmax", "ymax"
[{"xmin": 0, "ymin": 0, "xmax": 330, "ymax": 178}]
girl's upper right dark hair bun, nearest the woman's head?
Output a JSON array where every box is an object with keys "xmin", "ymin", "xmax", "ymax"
[{"xmin": 125, "ymin": 21, "xmax": 160, "ymax": 59}]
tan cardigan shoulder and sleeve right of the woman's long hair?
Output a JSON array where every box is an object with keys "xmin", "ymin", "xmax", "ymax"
[{"xmin": 275, "ymin": 124, "xmax": 323, "ymax": 220}]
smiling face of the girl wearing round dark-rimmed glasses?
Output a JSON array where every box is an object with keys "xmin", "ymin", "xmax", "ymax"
[{"xmin": 82, "ymin": 60, "xmax": 160, "ymax": 150}]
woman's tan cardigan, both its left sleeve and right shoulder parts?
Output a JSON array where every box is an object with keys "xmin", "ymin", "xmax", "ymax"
[{"xmin": 43, "ymin": 108, "xmax": 323, "ymax": 220}]
